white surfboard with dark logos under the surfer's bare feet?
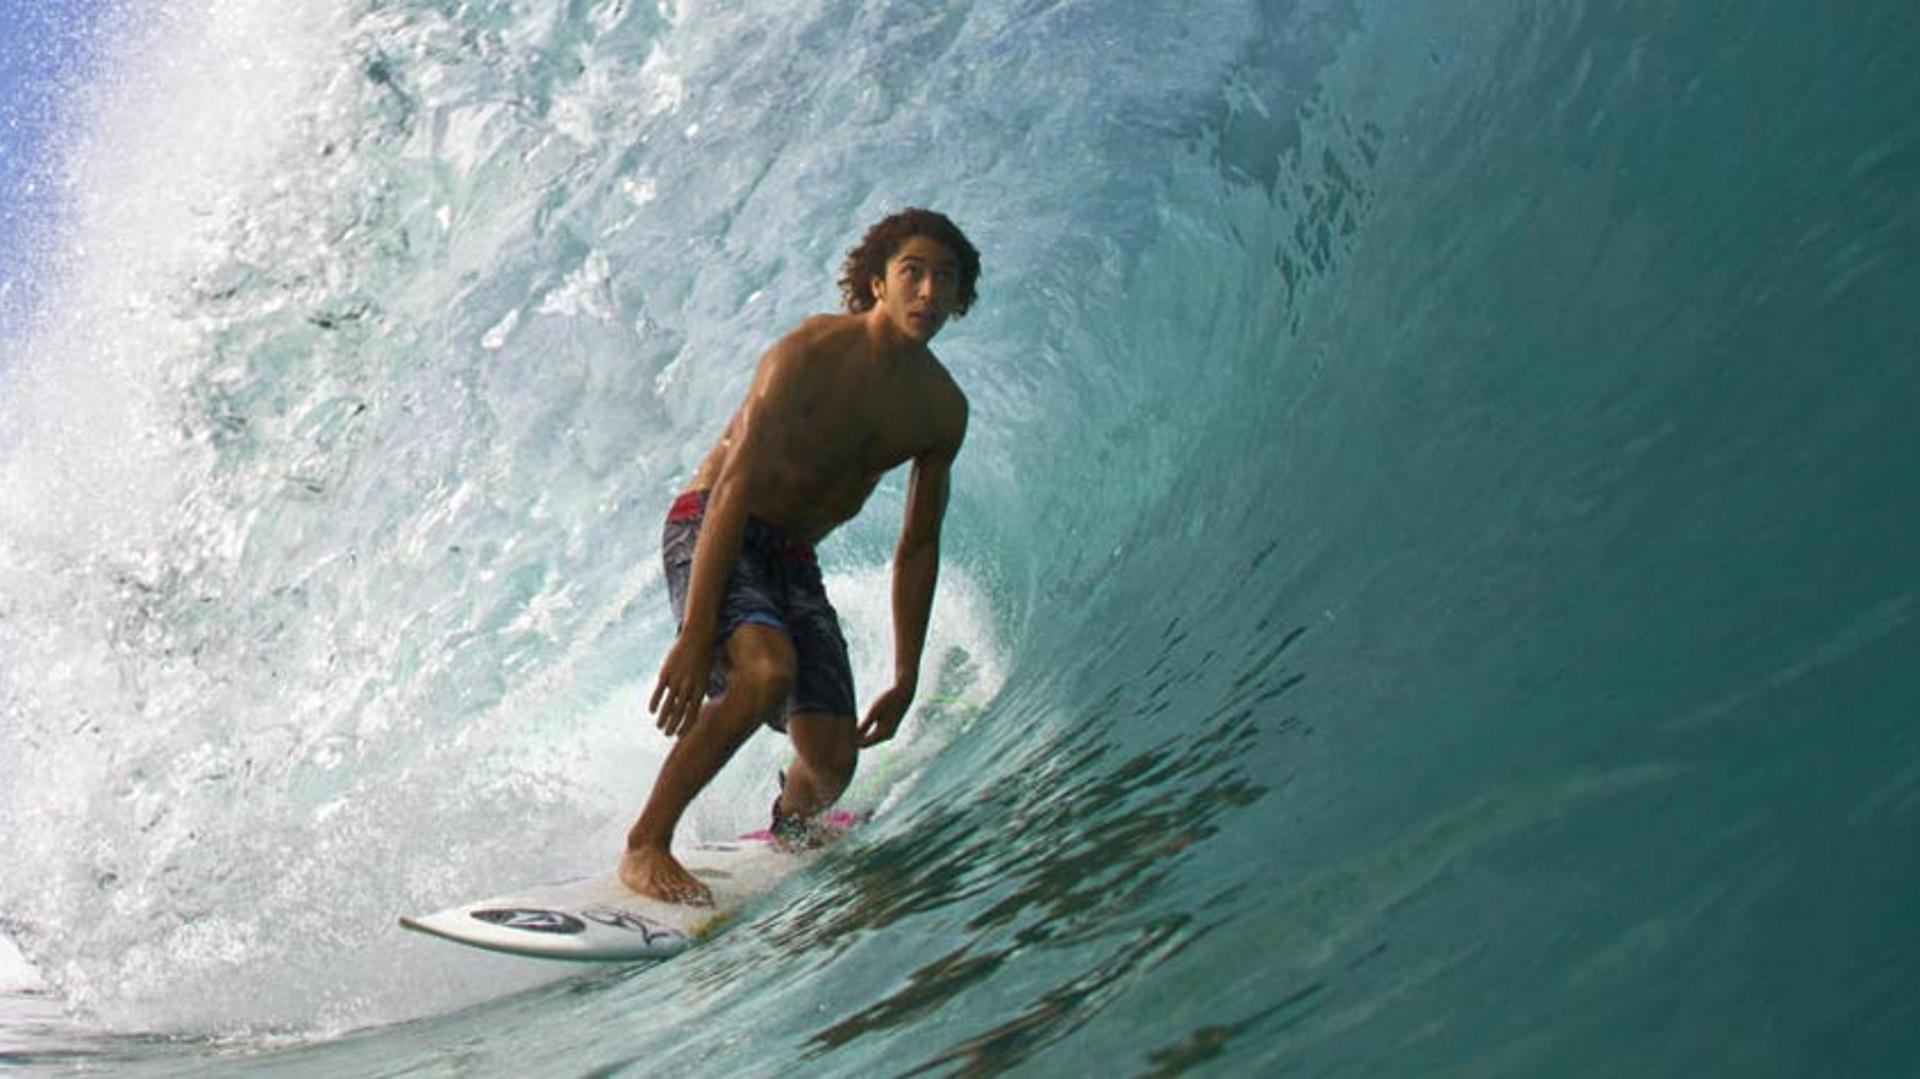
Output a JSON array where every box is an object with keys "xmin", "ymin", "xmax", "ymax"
[{"xmin": 399, "ymin": 833, "xmax": 814, "ymax": 962}]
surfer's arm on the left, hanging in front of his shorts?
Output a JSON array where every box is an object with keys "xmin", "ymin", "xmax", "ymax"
[{"xmin": 647, "ymin": 338, "xmax": 801, "ymax": 737}]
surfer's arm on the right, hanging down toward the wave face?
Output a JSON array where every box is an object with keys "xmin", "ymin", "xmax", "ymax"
[{"xmin": 860, "ymin": 407, "xmax": 966, "ymax": 747}]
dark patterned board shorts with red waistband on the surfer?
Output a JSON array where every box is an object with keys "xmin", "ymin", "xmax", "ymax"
[{"xmin": 660, "ymin": 492, "xmax": 854, "ymax": 731}]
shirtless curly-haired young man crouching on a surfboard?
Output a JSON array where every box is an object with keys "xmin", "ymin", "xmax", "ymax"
[{"xmin": 620, "ymin": 209, "xmax": 979, "ymax": 906}]
